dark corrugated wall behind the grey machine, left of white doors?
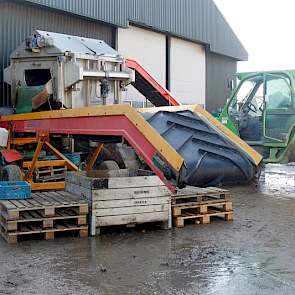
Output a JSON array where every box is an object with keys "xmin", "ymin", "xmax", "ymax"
[{"xmin": 0, "ymin": 1, "xmax": 115, "ymax": 106}]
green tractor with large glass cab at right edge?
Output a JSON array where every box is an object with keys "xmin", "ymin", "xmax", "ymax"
[{"xmin": 219, "ymin": 70, "xmax": 295, "ymax": 163}]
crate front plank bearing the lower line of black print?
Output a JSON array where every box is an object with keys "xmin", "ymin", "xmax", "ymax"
[{"xmin": 92, "ymin": 196, "xmax": 170, "ymax": 210}]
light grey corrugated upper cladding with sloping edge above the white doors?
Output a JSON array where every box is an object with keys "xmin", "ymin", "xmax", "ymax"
[{"xmin": 24, "ymin": 0, "xmax": 248, "ymax": 60}]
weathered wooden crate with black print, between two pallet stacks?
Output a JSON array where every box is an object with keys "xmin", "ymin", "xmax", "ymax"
[{"xmin": 66, "ymin": 170, "xmax": 172, "ymax": 235}]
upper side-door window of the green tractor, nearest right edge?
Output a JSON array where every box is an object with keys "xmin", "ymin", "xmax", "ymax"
[{"xmin": 265, "ymin": 75, "xmax": 292, "ymax": 109}]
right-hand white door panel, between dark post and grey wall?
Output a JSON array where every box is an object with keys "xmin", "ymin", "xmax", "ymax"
[{"xmin": 170, "ymin": 38, "xmax": 206, "ymax": 106}]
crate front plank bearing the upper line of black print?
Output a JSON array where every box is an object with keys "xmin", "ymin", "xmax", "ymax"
[{"xmin": 92, "ymin": 186, "xmax": 171, "ymax": 201}]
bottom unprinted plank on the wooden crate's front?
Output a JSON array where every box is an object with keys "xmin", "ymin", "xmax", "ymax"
[{"xmin": 96, "ymin": 211, "xmax": 168, "ymax": 227}]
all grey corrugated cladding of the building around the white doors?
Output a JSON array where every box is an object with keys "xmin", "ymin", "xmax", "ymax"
[{"xmin": 0, "ymin": 0, "xmax": 248, "ymax": 111}]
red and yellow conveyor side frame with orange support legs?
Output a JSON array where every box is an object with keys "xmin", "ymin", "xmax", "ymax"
[{"xmin": 0, "ymin": 105, "xmax": 185, "ymax": 192}]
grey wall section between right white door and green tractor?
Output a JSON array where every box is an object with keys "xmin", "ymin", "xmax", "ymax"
[{"xmin": 206, "ymin": 52, "xmax": 237, "ymax": 112}]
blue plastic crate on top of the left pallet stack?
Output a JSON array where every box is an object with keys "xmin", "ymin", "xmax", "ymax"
[{"xmin": 0, "ymin": 181, "xmax": 31, "ymax": 200}]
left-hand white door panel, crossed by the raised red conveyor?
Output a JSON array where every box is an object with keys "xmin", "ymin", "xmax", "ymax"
[{"xmin": 118, "ymin": 26, "xmax": 166, "ymax": 106}]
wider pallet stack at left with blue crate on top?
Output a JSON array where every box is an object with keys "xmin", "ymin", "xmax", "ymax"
[{"xmin": 0, "ymin": 192, "xmax": 88, "ymax": 243}]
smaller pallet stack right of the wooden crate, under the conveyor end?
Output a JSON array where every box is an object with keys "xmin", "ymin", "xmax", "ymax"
[{"xmin": 171, "ymin": 187, "xmax": 234, "ymax": 227}]
